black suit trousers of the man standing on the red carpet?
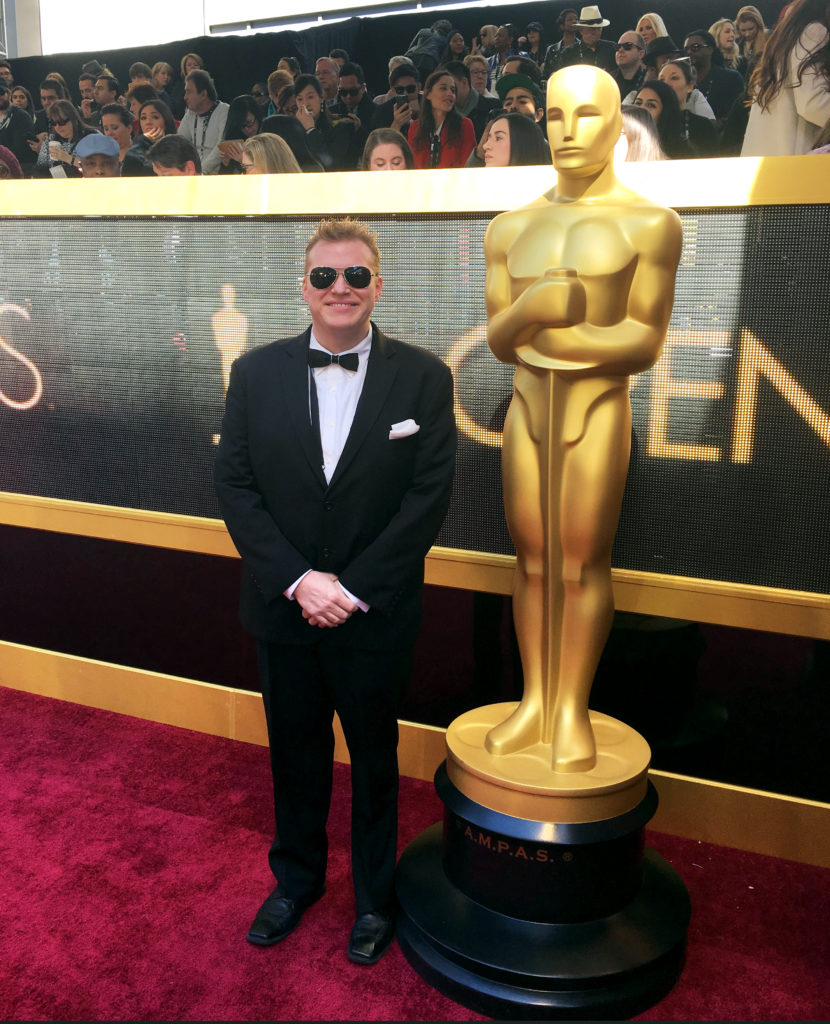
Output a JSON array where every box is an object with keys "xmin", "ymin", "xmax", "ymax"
[{"xmin": 258, "ymin": 638, "xmax": 412, "ymax": 913}]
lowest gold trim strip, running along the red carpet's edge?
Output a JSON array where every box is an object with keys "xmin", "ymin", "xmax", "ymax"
[{"xmin": 0, "ymin": 641, "xmax": 830, "ymax": 867}]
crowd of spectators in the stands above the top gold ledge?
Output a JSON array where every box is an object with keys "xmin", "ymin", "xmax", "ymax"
[{"xmin": 0, "ymin": 0, "xmax": 830, "ymax": 178}]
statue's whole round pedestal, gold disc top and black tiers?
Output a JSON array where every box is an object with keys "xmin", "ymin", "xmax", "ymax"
[{"xmin": 397, "ymin": 705, "xmax": 690, "ymax": 1020}]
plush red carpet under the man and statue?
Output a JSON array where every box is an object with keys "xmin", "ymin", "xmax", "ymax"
[{"xmin": 0, "ymin": 688, "xmax": 830, "ymax": 1021}]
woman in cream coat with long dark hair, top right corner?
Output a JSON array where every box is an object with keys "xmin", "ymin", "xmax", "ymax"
[{"xmin": 741, "ymin": 0, "xmax": 830, "ymax": 157}]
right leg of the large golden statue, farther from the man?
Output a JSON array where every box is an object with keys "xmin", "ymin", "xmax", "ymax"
[{"xmin": 553, "ymin": 388, "xmax": 630, "ymax": 772}]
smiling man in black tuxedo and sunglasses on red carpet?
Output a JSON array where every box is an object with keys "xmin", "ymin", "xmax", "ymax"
[{"xmin": 215, "ymin": 219, "xmax": 455, "ymax": 964}]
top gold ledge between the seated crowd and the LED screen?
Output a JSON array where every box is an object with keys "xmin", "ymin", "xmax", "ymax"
[{"xmin": 0, "ymin": 156, "xmax": 827, "ymax": 217}]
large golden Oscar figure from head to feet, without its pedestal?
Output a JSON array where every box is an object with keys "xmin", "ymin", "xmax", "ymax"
[{"xmin": 484, "ymin": 66, "xmax": 682, "ymax": 772}]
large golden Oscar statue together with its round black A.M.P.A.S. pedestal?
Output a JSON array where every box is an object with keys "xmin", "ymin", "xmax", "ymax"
[{"xmin": 397, "ymin": 66, "xmax": 690, "ymax": 1019}]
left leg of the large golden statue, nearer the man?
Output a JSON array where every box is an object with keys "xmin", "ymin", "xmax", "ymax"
[{"xmin": 485, "ymin": 380, "xmax": 549, "ymax": 754}]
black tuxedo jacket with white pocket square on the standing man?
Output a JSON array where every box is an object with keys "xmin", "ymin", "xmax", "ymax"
[{"xmin": 215, "ymin": 326, "xmax": 455, "ymax": 649}]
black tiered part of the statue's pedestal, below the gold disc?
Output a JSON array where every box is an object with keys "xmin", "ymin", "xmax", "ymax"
[{"xmin": 397, "ymin": 765, "xmax": 690, "ymax": 1020}]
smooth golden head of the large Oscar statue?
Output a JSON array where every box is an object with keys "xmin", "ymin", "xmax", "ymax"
[{"xmin": 545, "ymin": 65, "xmax": 622, "ymax": 175}]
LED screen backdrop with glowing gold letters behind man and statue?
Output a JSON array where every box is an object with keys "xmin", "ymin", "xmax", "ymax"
[{"xmin": 0, "ymin": 205, "xmax": 830, "ymax": 593}]
